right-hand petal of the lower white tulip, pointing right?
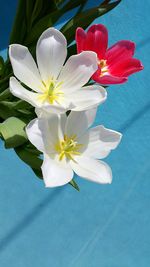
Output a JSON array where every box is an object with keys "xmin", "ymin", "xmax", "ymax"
[{"xmin": 83, "ymin": 125, "xmax": 122, "ymax": 159}]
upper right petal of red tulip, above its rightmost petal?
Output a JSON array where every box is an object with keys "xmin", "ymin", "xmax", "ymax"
[{"xmin": 105, "ymin": 40, "xmax": 135, "ymax": 65}]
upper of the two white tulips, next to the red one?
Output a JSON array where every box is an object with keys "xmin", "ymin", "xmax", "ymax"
[{"xmin": 9, "ymin": 28, "xmax": 106, "ymax": 113}]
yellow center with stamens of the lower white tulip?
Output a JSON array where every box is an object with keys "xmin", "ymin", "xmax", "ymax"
[{"xmin": 55, "ymin": 134, "xmax": 83, "ymax": 161}]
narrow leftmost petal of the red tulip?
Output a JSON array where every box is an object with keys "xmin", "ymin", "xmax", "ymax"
[{"xmin": 75, "ymin": 27, "xmax": 86, "ymax": 53}]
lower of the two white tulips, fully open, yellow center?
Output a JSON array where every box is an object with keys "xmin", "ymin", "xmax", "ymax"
[{"xmin": 26, "ymin": 109, "xmax": 121, "ymax": 187}]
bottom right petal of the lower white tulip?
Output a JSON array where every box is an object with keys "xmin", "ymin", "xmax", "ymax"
[{"xmin": 70, "ymin": 156, "xmax": 112, "ymax": 184}]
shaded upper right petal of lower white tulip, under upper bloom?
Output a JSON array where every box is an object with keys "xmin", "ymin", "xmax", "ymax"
[{"xmin": 65, "ymin": 108, "xmax": 97, "ymax": 137}]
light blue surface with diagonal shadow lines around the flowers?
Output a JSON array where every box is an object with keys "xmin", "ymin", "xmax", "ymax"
[{"xmin": 0, "ymin": 0, "xmax": 150, "ymax": 267}]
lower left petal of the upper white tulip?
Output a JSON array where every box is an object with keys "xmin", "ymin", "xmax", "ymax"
[{"xmin": 9, "ymin": 77, "xmax": 41, "ymax": 107}]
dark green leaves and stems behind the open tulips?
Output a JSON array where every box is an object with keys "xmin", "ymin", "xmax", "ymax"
[{"xmin": 0, "ymin": 0, "xmax": 121, "ymax": 191}]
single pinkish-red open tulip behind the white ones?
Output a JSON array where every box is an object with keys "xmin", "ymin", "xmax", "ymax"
[{"xmin": 76, "ymin": 24, "xmax": 143, "ymax": 84}]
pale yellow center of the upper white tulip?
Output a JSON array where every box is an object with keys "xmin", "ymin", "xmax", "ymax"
[{"xmin": 39, "ymin": 80, "xmax": 64, "ymax": 104}]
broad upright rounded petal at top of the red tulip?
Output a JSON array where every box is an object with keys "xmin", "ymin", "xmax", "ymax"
[{"xmin": 86, "ymin": 24, "xmax": 108, "ymax": 59}]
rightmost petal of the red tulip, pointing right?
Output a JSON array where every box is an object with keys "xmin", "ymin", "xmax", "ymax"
[{"xmin": 109, "ymin": 58, "xmax": 143, "ymax": 77}]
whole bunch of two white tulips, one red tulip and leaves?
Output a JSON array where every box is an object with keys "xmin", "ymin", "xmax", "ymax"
[{"xmin": 0, "ymin": 0, "xmax": 143, "ymax": 190}]
